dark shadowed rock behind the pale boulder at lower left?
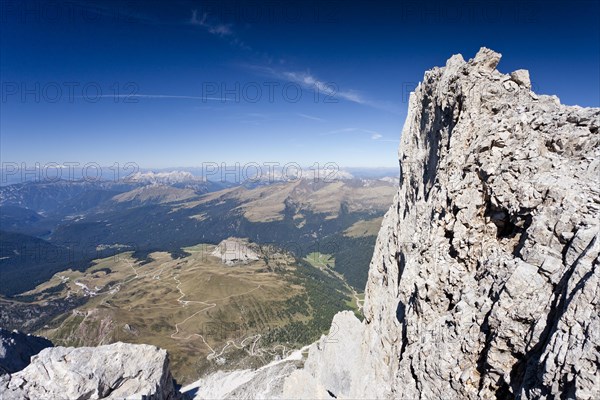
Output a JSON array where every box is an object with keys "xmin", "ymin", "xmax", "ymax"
[{"xmin": 0, "ymin": 328, "xmax": 52, "ymax": 375}]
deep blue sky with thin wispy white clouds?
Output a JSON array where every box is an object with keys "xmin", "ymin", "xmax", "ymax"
[{"xmin": 0, "ymin": 0, "xmax": 600, "ymax": 168}]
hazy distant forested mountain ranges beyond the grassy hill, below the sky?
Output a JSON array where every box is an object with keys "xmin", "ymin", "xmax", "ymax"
[{"xmin": 0, "ymin": 177, "xmax": 396, "ymax": 295}]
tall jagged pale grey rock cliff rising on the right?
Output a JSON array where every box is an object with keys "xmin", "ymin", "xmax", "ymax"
[{"xmin": 190, "ymin": 48, "xmax": 600, "ymax": 400}]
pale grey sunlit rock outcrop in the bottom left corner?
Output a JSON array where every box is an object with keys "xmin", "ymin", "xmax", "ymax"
[{"xmin": 0, "ymin": 343, "xmax": 180, "ymax": 400}]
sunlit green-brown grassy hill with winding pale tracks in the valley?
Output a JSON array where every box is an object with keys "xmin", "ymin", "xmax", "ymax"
[{"xmin": 27, "ymin": 245, "xmax": 350, "ymax": 383}]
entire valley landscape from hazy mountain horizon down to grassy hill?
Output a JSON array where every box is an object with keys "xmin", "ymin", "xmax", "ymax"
[{"xmin": 0, "ymin": 172, "xmax": 397, "ymax": 382}]
